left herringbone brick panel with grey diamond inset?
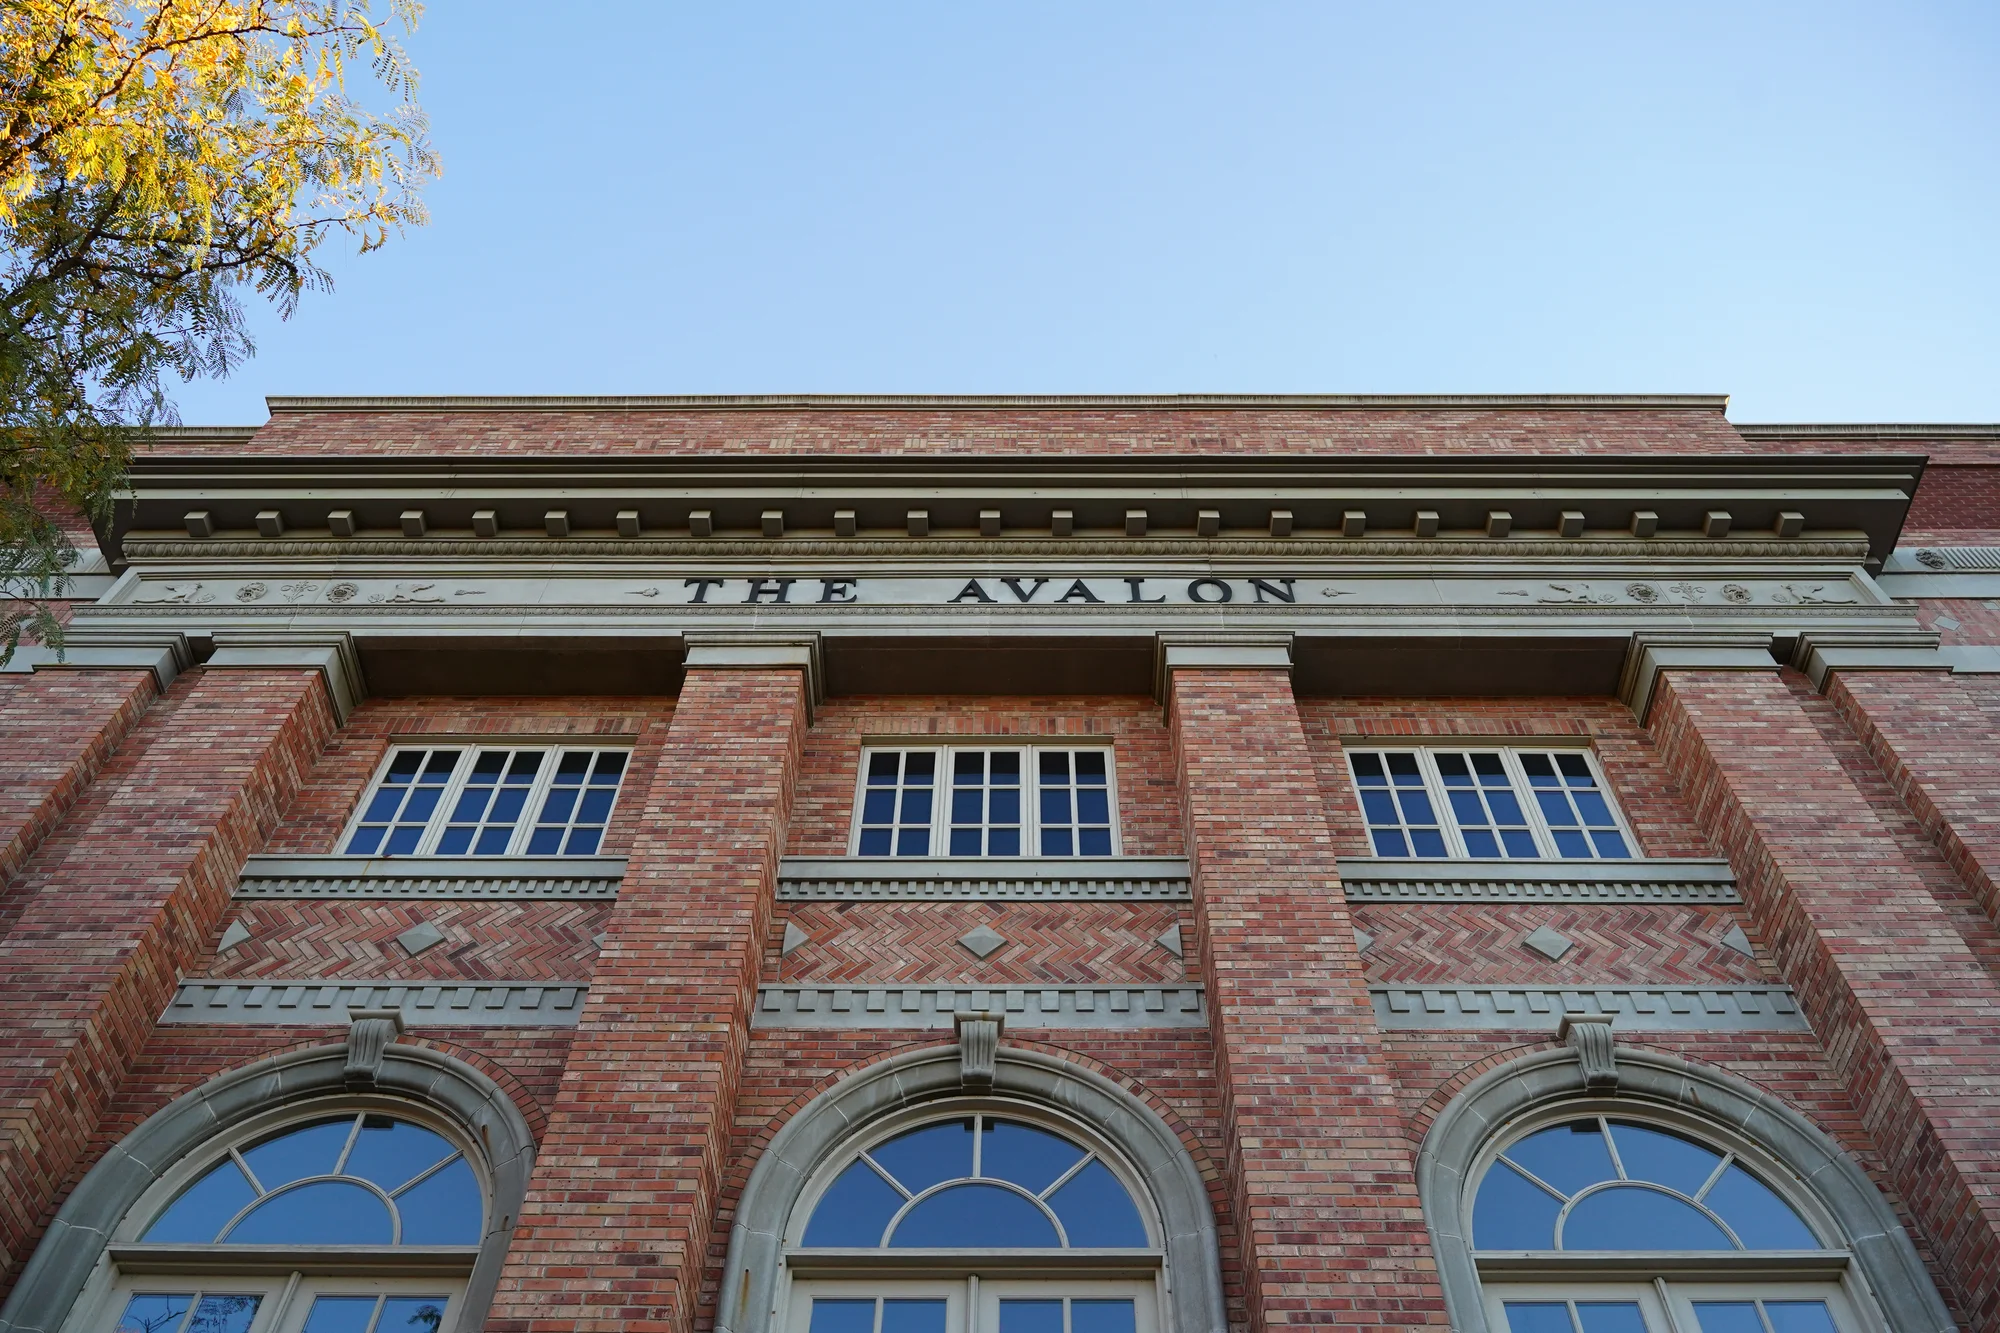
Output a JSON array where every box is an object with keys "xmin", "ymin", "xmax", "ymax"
[{"xmin": 204, "ymin": 899, "xmax": 612, "ymax": 981}]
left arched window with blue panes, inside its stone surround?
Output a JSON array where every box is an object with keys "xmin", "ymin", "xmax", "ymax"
[{"xmin": 77, "ymin": 1099, "xmax": 488, "ymax": 1333}]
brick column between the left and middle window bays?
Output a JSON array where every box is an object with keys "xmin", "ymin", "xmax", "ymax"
[{"xmin": 486, "ymin": 648, "xmax": 808, "ymax": 1333}]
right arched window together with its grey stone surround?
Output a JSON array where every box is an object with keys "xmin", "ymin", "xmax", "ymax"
[{"xmin": 1418, "ymin": 1045, "xmax": 1952, "ymax": 1333}]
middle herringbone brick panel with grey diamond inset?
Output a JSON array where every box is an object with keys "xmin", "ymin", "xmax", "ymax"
[{"xmin": 766, "ymin": 903, "xmax": 1194, "ymax": 983}]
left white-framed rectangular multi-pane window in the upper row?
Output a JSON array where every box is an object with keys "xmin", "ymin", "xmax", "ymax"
[{"xmin": 342, "ymin": 745, "xmax": 628, "ymax": 857}]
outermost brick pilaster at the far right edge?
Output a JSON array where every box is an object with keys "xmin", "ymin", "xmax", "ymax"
[{"xmin": 1824, "ymin": 671, "xmax": 2000, "ymax": 921}]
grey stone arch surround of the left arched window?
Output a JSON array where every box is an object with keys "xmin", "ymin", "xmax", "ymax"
[{"xmin": 0, "ymin": 1043, "xmax": 534, "ymax": 1333}]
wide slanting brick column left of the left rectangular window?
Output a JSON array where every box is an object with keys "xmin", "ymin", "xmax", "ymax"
[{"xmin": 0, "ymin": 669, "xmax": 334, "ymax": 1281}]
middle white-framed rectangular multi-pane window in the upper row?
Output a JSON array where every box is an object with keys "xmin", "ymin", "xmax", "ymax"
[{"xmin": 852, "ymin": 747, "xmax": 1118, "ymax": 857}]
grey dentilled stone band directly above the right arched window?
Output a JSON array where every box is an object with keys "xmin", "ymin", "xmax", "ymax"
[{"xmin": 1368, "ymin": 985, "xmax": 1812, "ymax": 1033}]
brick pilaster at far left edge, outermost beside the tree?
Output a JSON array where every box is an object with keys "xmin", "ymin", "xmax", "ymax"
[{"xmin": 0, "ymin": 671, "xmax": 158, "ymax": 887}]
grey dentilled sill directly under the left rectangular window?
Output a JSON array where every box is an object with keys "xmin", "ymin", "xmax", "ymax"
[{"xmin": 236, "ymin": 857, "xmax": 626, "ymax": 899}]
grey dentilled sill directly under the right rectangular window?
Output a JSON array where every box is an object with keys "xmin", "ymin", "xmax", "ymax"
[{"xmin": 1340, "ymin": 857, "xmax": 1742, "ymax": 903}]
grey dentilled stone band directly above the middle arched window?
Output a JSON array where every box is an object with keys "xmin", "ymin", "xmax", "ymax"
[{"xmin": 752, "ymin": 983, "xmax": 1208, "ymax": 1031}]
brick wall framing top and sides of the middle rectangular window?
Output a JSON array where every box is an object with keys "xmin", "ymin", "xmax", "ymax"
[{"xmin": 786, "ymin": 697, "xmax": 1182, "ymax": 857}]
